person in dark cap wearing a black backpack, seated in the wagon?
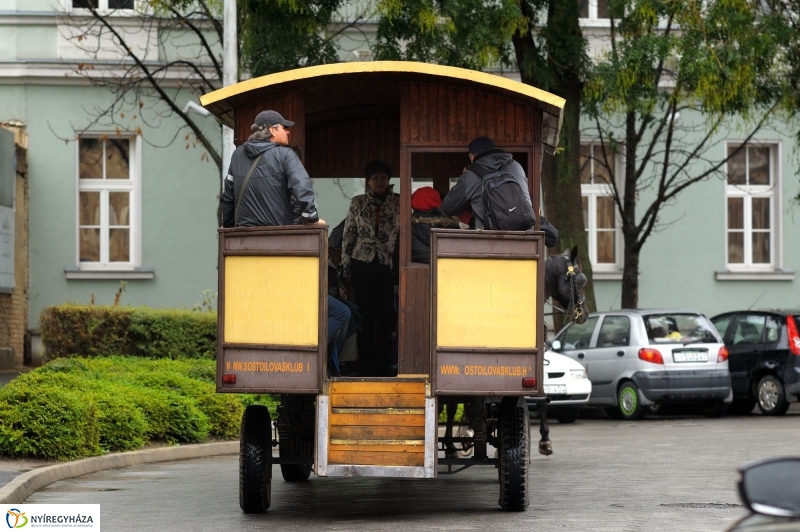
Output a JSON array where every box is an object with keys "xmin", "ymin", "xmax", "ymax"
[{"xmin": 440, "ymin": 137, "xmax": 558, "ymax": 247}]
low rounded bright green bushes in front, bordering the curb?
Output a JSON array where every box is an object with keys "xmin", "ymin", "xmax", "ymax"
[{"xmin": 0, "ymin": 356, "xmax": 266, "ymax": 460}]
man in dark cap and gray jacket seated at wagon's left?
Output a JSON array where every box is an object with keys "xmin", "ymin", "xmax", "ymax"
[{"xmin": 220, "ymin": 111, "xmax": 351, "ymax": 370}]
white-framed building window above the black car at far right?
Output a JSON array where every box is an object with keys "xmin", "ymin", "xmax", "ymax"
[{"xmin": 725, "ymin": 145, "xmax": 779, "ymax": 270}]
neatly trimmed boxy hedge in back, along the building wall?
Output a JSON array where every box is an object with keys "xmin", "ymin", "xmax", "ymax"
[{"xmin": 40, "ymin": 304, "xmax": 217, "ymax": 360}]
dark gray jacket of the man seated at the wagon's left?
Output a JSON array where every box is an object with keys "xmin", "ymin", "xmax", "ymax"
[{"xmin": 220, "ymin": 140, "xmax": 319, "ymax": 227}]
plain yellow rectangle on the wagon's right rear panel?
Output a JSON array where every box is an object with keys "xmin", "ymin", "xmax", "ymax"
[{"xmin": 436, "ymin": 259, "xmax": 539, "ymax": 349}]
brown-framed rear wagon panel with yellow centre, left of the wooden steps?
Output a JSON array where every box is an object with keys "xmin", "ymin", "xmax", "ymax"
[{"xmin": 217, "ymin": 226, "xmax": 328, "ymax": 393}]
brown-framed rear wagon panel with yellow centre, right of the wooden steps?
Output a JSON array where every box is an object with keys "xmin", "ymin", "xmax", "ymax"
[{"xmin": 431, "ymin": 229, "xmax": 544, "ymax": 396}]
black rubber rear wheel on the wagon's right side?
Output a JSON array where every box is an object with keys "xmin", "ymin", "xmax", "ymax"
[{"xmin": 499, "ymin": 397, "xmax": 530, "ymax": 511}]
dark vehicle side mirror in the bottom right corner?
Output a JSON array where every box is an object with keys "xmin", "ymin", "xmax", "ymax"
[{"xmin": 739, "ymin": 458, "xmax": 800, "ymax": 517}]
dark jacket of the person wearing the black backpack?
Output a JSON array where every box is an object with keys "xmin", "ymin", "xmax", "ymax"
[{"xmin": 441, "ymin": 150, "xmax": 558, "ymax": 248}]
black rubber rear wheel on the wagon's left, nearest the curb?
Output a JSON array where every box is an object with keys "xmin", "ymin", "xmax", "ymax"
[{"xmin": 239, "ymin": 405, "xmax": 272, "ymax": 514}]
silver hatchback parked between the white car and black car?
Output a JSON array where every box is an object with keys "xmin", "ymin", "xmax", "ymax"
[{"xmin": 552, "ymin": 310, "xmax": 733, "ymax": 420}]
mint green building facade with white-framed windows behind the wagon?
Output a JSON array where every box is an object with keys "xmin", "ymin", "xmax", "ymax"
[{"xmin": 0, "ymin": 0, "xmax": 800, "ymax": 362}]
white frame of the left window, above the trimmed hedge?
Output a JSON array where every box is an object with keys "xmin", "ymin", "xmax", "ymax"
[{"xmin": 75, "ymin": 135, "xmax": 142, "ymax": 272}]
